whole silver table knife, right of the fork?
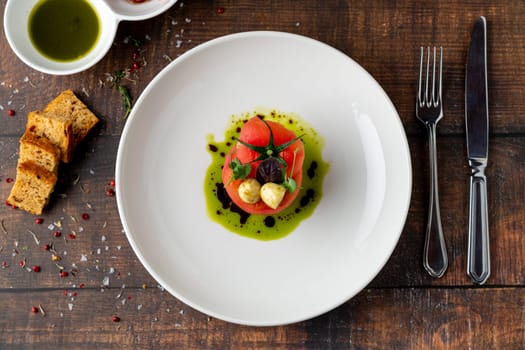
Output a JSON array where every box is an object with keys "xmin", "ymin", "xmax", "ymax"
[{"xmin": 465, "ymin": 17, "xmax": 490, "ymax": 284}]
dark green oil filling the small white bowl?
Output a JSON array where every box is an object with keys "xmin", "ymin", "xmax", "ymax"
[{"xmin": 28, "ymin": 0, "xmax": 100, "ymax": 62}]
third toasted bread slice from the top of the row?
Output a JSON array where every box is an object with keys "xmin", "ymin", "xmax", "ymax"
[{"xmin": 18, "ymin": 130, "xmax": 60, "ymax": 175}]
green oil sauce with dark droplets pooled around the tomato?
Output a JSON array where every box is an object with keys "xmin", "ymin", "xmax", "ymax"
[{"xmin": 204, "ymin": 108, "xmax": 330, "ymax": 241}]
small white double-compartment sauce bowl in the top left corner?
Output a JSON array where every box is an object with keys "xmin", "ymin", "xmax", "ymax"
[{"xmin": 4, "ymin": 0, "xmax": 177, "ymax": 75}]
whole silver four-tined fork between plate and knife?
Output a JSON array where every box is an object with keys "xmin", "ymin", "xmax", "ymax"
[{"xmin": 416, "ymin": 47, "xmax": 448, "ymax": 278}]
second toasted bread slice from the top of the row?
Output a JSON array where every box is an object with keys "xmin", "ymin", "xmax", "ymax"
[{"xmin": 26, "ymin": 111, "xmax": 75, "ymax": 163}]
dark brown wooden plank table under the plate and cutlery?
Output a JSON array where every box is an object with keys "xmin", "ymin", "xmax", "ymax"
[{"xmin": 0, "ymin": 0, "xmax": 525, "ymax": 349}]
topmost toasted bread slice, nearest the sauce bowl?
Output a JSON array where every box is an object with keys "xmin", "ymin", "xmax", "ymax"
[{"xmin": 44, "ymin": 90, "xmax": 99, "ymax": 145}]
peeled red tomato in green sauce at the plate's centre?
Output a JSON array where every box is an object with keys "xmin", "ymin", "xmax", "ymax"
[{"xmin": 222, "ymin": 117, "xmax": 304, "ymax": 215}]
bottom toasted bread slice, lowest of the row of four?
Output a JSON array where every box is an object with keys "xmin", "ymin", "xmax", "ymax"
[{"xmin": 7, "ymin": 161, "xmax": 57, "ymax": 215}]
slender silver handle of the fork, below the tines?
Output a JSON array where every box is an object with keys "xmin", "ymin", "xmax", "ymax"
[{"xmin": 423, "ymin": 123, "xmax": 448, "ymax": 278}]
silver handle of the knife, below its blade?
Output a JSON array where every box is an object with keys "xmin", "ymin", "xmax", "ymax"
[{"xmin": 467, "ymin": 168, "xmax": 490, "ymax": 284}]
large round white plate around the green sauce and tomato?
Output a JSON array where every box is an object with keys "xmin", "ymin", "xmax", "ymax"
[{"xmin": 116, "ymin": 32, "xmax": 412, "ymax": 325}]
